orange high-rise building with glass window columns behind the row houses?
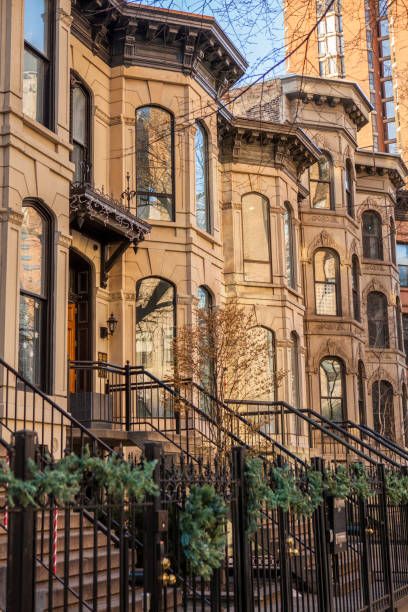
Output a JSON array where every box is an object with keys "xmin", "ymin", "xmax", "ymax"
[{"xmin": 285, "ymin": 0, "xmax": 408, "ymax": 159}]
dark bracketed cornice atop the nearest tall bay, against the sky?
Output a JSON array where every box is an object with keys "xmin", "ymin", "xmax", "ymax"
[{"xmin": 72, "ymin": 0, "xmax": 247, "ymax": 96}]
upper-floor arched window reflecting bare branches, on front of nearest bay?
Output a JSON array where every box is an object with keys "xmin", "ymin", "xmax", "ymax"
[{"xmin": 136, "ymin": 106, "xmax": 175, "ymax": 221}]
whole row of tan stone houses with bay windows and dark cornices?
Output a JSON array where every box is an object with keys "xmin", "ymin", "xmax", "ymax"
[{"xmin": 0, "ymin": 0, "xmax": 407, "ymax": 454}]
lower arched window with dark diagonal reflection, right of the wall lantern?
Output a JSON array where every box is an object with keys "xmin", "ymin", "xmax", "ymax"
[{"xmin": 136, "ymin": 276, "xmax": 176, "ymax": 379}]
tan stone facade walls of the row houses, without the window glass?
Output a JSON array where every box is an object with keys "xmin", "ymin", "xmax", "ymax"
[{"xmin": 0, "ymin": 0, "xmax": 406, "ymax": 439}]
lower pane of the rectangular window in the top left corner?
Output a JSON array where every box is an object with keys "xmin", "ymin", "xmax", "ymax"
[{"xmin": 23, "ymin": 49, "xmax": 46, "ymax": 123}]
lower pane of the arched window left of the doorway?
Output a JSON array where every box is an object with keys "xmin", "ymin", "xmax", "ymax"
[{"xmin": 18, "ymin": 295, "xmax": 44, "ymax": 386}]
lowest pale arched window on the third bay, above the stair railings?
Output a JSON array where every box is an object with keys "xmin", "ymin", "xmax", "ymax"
[{"xmin": 320, "ymin": 357, "xmax": 346, "ymax": 422}]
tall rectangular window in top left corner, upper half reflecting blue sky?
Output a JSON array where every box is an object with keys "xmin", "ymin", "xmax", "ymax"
[{"xmin": 23, "ymin": 0, "xmax": 54, "ymax": 127}]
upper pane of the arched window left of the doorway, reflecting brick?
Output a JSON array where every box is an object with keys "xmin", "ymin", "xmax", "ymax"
[{"xmin": 20, "ymin": 206, "xmax": 46, "ymax": 295}]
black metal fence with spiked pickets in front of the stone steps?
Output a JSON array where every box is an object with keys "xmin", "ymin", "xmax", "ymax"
[{"xmin": 0, "ymin": 431, "xmax": 408, "ymax": 612}]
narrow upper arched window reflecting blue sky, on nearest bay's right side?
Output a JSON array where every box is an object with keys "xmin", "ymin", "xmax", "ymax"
[{"xmin": 194, "ymin": 121, "xmax": 211, "ymax": 232}]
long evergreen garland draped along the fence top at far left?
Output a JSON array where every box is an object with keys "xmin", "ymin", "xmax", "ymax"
[{"xmin": 0, "ymin": 452, "xmax": 159, "ymax": 508}]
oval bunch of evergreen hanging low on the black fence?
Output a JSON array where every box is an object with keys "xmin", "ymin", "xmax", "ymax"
[{"xmin": 179, "ymin": 484, "xmax": 227, "ymax": 580}]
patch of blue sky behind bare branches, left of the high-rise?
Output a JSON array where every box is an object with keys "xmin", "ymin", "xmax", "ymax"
[{"xmin": 129, "ymin": 0, "xmax": 284, "ymax": 81}]
